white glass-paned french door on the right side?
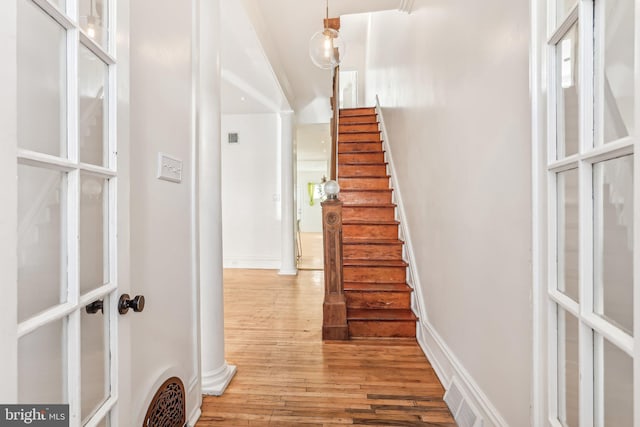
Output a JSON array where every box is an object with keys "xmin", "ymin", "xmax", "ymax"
[{"xmin": 547, "ymin": 0, "xmax": 640, "ymax": 427}]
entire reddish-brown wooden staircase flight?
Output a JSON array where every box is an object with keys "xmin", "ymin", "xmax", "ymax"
[{"xmin": 337, "ymin": 108, "xmax": 417, "ymax": 338}]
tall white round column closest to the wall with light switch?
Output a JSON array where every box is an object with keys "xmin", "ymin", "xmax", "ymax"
[{"xmin": 196, "ymin": 0, "xmax": 236, "ymax": 395}]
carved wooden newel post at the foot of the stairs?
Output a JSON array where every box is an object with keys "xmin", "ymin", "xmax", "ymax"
[{"xmin": 322, "ymin": 199, "xmax": 349, "ymax": 340}]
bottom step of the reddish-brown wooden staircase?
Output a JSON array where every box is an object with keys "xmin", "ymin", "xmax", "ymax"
[{"xmin": 347, "ymin": 309, "xmax": 417, "ymax": 338}]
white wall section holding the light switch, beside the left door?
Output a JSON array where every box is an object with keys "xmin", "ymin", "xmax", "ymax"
[{"xmin": 129, "ymin": 0, "xmax": 199, "ymax": 425}]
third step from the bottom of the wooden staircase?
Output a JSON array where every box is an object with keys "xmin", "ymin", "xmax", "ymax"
[{"xmin": 343, "ymin": 259, "xmax": 407, "ymax": 283}]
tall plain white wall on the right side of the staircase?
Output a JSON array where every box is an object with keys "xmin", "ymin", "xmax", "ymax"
[{"xmin": 366, "ymin": 0, "xmax": 532, "ymax": 426}]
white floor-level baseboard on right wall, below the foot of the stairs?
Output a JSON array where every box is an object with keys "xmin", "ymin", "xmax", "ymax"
[{"xmin": 417, "ymin": 318, "xmax": 509, "ymax": 427}]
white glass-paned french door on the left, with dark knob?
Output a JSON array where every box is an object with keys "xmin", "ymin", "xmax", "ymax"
[{"xmin": 16, "ymin": 0, "xmax": 118, "ymax": 426}]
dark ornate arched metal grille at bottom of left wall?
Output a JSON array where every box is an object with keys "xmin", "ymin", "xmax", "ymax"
[{"xmin": 142, "ymin": 377, "xmax": 187, "ymax": 427}]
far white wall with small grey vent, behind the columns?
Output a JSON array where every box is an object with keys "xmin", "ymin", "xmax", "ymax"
[{"xmin": 221, "ymin": 114, "xmax": 281, "ymax": 269}]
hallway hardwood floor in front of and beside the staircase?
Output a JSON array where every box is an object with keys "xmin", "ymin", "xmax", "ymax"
[{"xmin": 197, "ymin": 270, "xmax": 456, "ymax": 427}]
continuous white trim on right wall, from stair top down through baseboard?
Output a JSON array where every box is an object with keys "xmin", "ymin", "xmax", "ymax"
[{"xmin": 375, "ymin": 95, "xmax": 509, "ymax": 427}]
